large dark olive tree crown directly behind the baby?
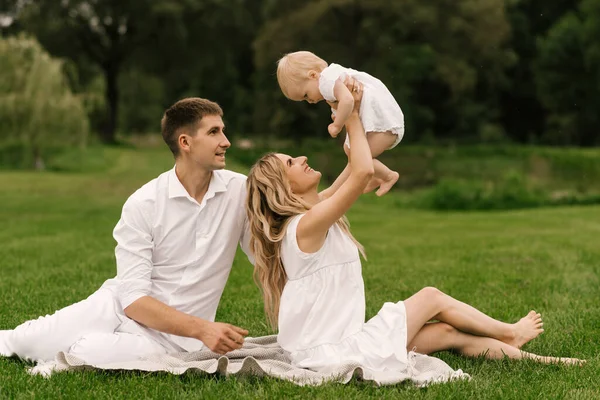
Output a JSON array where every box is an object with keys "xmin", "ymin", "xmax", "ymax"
[{"xmin": 254, "ymin": 0, "xmax": 513, "ymax": 143}]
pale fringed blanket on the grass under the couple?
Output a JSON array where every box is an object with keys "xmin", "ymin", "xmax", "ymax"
[{"xmin": 29, "ymin": 335, "xmax": 469, "ymax": 386}]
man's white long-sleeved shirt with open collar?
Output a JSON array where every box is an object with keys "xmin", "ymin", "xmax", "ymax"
[{"xmin": 104, "ymin": 168, "xmax": 249, "ymax": 351}]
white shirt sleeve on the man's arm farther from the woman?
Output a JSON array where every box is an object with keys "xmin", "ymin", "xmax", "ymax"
[{"xmin": 113, "ymin": 198, "xmax": 154, "ymax": 309}]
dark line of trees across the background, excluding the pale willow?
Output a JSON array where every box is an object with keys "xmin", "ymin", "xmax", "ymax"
[{"xmin": 0, "ymin": 0, "xmax": 600, "ymax": 146}]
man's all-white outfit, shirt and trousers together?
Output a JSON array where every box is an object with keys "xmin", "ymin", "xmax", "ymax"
[{"xmin": 0, "ymin": 169, "xmax": 249, "ymax": 361}]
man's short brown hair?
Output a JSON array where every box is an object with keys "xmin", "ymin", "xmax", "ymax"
[{"xmin": 160, "ymin": 97, "xmax": 223, "ymax": 158}]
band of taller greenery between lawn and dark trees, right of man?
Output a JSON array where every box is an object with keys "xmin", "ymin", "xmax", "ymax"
[{"xmin": 228, "ymin": 140, "xmax": 600, "ymax": 210}]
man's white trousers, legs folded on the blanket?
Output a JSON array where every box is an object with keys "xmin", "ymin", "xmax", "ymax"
[{"xmin": 0, "ymin": 289, "xmax": 167, "ymax": 363}]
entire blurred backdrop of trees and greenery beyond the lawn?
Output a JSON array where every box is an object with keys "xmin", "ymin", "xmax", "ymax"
[{"xmin": 0, "ymin": 0, "xmax": 600, "ymax": 209}]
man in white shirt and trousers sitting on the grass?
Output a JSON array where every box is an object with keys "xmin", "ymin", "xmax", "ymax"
[{"xmin": 0, "ymin": 98, "xmax": 248, "ymax": 364}]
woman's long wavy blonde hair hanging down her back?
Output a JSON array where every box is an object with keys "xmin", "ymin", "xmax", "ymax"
[{"xmin": 246, "ymin": 153, "xmax": 366, "ymax": 330}]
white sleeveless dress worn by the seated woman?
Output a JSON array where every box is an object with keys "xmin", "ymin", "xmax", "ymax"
[{"xmin": 278, "ymin": 214, "xmax": 408, "ymax": 373}]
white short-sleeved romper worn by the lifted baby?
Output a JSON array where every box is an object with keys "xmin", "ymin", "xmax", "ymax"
[{"xmin": 319, "ymin": 63, "xmax": 404, "ymax": 148}]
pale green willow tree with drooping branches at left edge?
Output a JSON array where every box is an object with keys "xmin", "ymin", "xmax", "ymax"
[{"xmin": 0, "ymin": 36, "xmax": 88, "ymax": 168}]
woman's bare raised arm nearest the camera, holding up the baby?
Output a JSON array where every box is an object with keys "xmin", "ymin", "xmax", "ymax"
[{"xmin": 296, "ymin": 82, "xmax": 373, "ymax": 253}]
